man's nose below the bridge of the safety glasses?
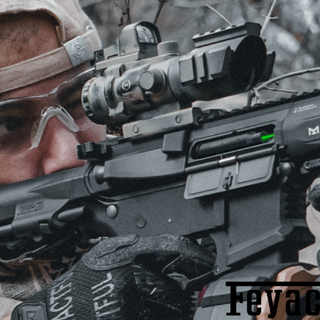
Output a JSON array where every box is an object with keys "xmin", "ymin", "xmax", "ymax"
[{"xmin": 38, "ymin": 116, "xmax": 86, "ymax": 175}]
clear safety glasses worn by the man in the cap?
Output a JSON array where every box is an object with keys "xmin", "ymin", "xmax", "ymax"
[{"xmin": 0, "ymin": 69, "xmax": 94, "ymax": 156}]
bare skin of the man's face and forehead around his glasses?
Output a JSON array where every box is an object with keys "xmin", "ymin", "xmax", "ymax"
[{"xmin": 0, "ymin": 15, "xmax": 106, "ymax": 185}]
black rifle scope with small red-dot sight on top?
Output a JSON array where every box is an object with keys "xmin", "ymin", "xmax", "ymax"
[{"xmin": 82, "ymin": 22, "xmax": 271, "ymax": 124}]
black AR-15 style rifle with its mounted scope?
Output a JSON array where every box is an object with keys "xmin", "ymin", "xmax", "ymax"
[{"xmin": 0, "ymin": 22, "xmax": 320, "ymax": 320}]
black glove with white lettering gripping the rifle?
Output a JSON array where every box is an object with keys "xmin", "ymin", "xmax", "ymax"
[{"xmin": 11, "ymin": 235, "xmax": 215, "ymax": 320}]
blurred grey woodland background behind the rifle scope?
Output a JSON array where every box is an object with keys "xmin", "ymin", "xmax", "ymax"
[{"xmin": 80, "ymin": 0, "xmax": 320, "ymax": 109}]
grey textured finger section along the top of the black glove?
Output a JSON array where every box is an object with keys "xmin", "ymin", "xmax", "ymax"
[{"xmin": 83, "ymin": 235, "xmax": 215, "ymax": 276}]
